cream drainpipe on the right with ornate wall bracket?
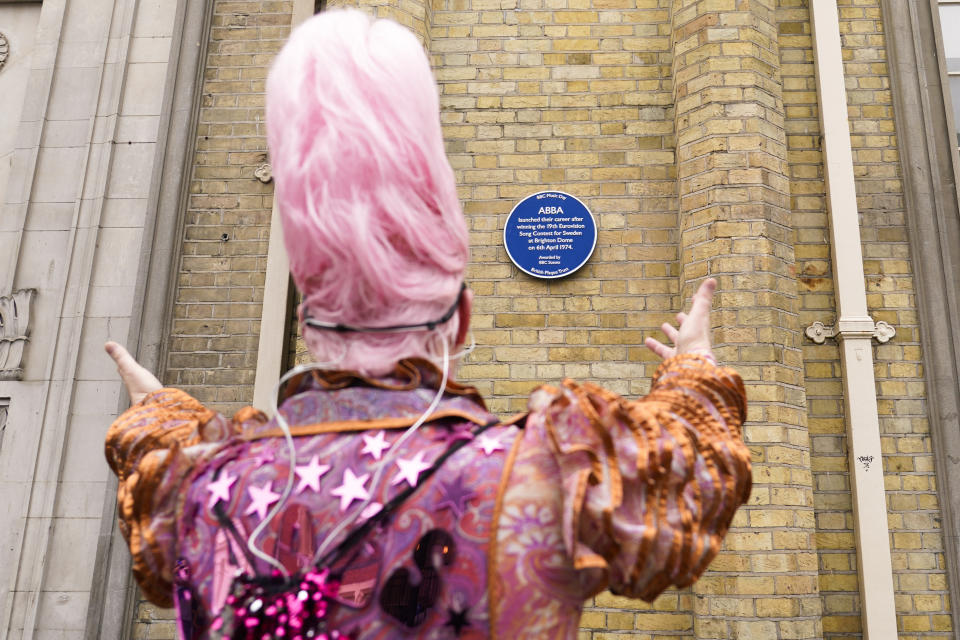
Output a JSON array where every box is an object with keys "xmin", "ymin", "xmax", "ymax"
[{"xmin": 810, "ymin": 0, "xmax": 897, "ymax": 640}]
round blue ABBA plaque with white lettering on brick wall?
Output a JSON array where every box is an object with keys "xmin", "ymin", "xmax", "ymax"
[{"xmin": 503, "ymin": 191, "xmax": 597, "ymax": 278}]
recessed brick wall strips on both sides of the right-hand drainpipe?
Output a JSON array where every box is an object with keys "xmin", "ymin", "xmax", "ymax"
[{"xmin": 778, "ymin": 0, "xmax": 953, "ymax": 638}]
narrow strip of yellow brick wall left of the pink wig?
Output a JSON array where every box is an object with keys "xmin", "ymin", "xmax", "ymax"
[{"xmin": 164, "ymin": 0, "xmax": 293, "ymax": 412}]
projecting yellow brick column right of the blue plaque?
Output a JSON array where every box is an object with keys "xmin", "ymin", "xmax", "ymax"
[{"xmin": 673, "ymin": 0, "xmax": 822, "ymax": 640}]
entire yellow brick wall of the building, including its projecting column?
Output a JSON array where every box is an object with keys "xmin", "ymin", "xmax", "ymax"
[{"xmin": 136, "ymin": 0, "xmax": 950, "ymax": 640}]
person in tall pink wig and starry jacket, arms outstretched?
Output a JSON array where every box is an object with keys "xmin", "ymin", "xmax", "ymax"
[{"xmin": 106, "ymin": 10, "xmax": 751, "ymax": 640}]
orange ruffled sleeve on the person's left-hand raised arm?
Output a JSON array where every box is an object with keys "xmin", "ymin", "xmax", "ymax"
[{"xmin": 106, "ymin": 389, "xmax": 266, "ymax": 607}]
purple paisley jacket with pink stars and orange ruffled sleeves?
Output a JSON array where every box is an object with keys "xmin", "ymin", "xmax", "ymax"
[{"xmin": 107, "ymin": 355, "xmax": 751, "ymax": 640}]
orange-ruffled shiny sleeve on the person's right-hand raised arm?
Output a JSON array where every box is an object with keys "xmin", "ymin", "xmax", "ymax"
[{"xmin": 535, "ymin": 354, "xmax": 752, "ymax": 601}]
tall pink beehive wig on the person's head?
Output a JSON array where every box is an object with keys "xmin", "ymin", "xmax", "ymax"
[{"xmin": 267, "ymin": 10, "xmax": 468, "ymax": 374}]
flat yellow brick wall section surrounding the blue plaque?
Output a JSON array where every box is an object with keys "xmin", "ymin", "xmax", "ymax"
[{"xmin": 431, "ymin": 0, "xmax": 677, "ymax": 412}]
